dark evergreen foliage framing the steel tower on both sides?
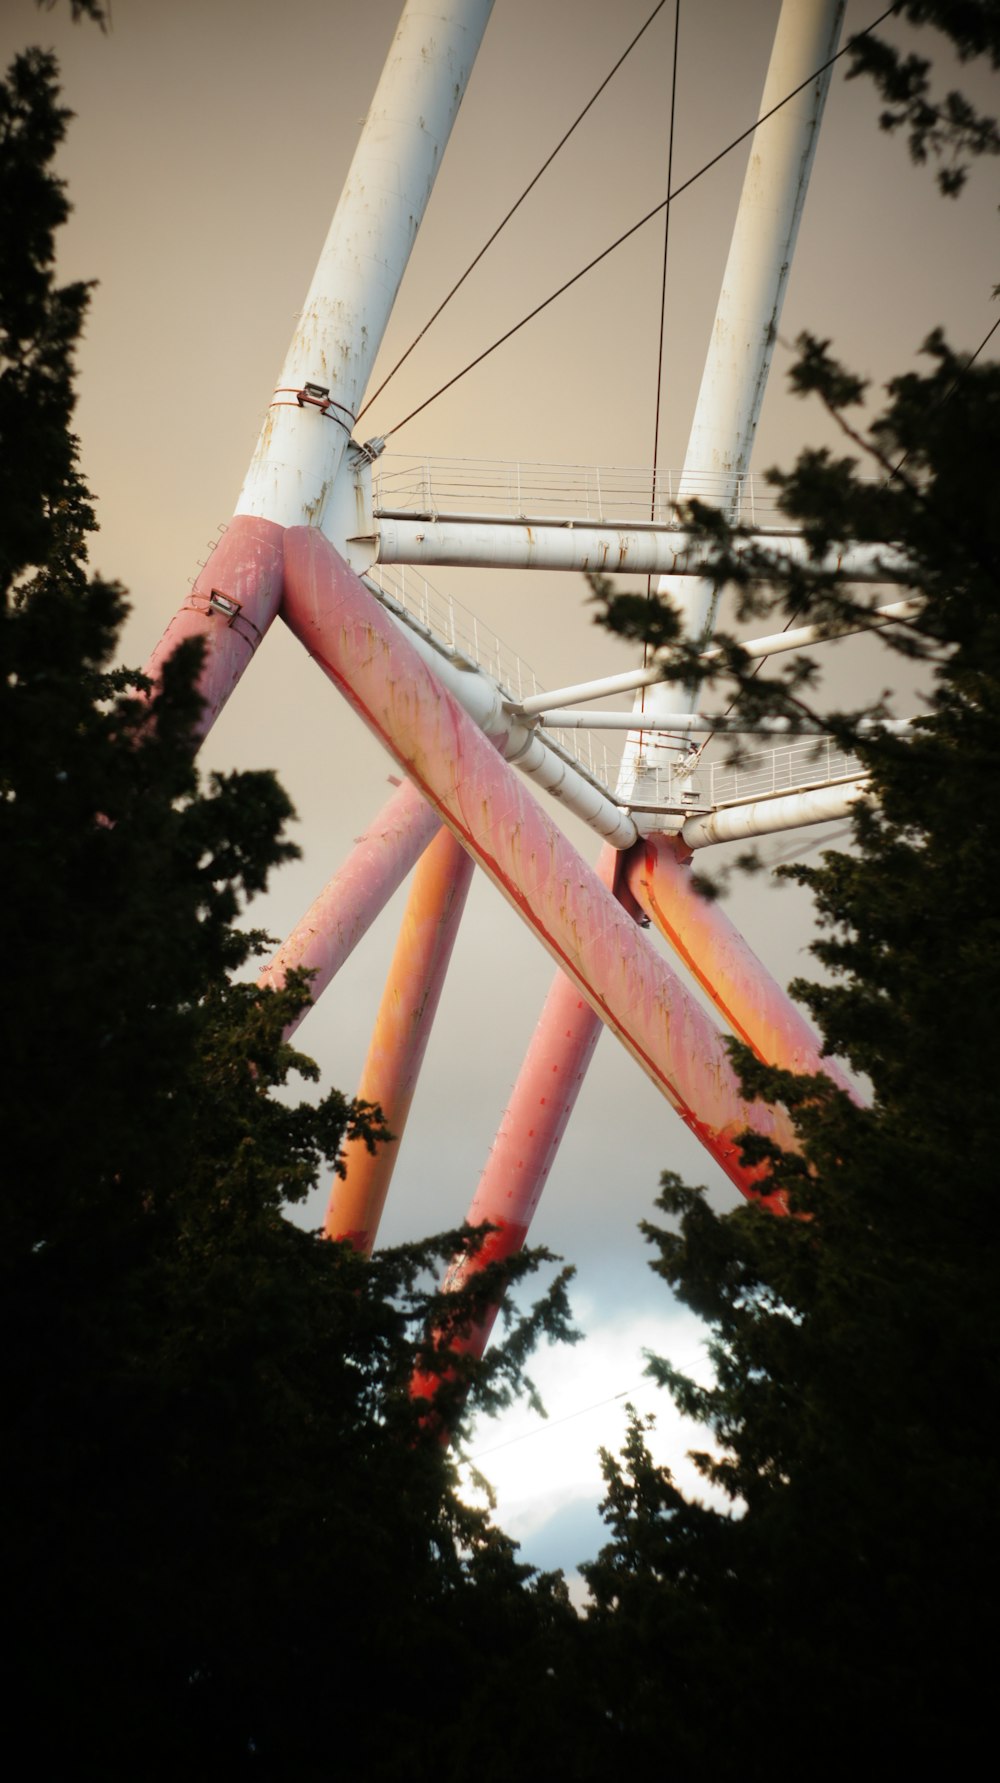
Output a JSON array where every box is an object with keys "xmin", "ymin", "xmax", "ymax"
[{"xmin": 0, "ymin": 0, "xmax": 1000, "ymax": 1779}]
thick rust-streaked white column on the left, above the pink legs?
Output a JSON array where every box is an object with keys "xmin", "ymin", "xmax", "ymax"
[{"xmin": 235, "ymin": 0, "xmax": 494, "ymax": 526}]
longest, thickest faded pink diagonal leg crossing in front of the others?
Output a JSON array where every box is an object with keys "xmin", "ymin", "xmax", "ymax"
[{"xmin": 276, "ymin": 528, "xmax": 795, "ymax": 1195}]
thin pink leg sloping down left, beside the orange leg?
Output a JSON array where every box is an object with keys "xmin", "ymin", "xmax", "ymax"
[{"xmin": 258, "ymin": 781, "xmax": 440, "ymax": 1034}]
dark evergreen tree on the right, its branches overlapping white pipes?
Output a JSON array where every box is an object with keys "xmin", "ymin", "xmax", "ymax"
[{"xmin": 585, "ymin": 9, "xmax": 1000, "ymax": 1776}]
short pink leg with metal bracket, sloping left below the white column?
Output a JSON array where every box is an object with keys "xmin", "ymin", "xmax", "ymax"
[{"xmin": 144, "ymin": 514, "xmax": 285, "ymax": 738}]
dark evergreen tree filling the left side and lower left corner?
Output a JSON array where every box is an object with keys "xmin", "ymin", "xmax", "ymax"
[{"xmin": 0, "ymin": 38, "xmax": 584, "ymax": 1778}]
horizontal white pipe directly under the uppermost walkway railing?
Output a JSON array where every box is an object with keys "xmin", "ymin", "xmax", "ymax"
[{"xmin": 376, "ymin": 521, "xmax": 913, "ymax": 583}]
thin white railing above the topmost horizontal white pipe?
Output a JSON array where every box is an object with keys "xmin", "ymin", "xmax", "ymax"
[{"xmin": 373, "ymin": 453, "xmax": 781, "ymax": 526}]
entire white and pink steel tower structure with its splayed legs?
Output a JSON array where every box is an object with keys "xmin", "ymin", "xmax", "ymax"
[{"xmin": 146, "ymin": 0, "xmax": 887, "ymax": 1346}]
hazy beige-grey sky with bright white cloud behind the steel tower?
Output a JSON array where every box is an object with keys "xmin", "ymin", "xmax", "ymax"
[{"xmin": 0, "ymin": 0, "xmax": 998, "ymax": 1590}]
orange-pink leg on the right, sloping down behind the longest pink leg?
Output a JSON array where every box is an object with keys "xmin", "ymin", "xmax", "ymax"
[{"xmin": 624, "ymin": 836, "xmax": 854, "ymax": 1095}]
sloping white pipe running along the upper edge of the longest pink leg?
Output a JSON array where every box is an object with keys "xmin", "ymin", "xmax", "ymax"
[{"xmin": 367, "ymin": 583, "xmax": 638, "ymax": 849}]
